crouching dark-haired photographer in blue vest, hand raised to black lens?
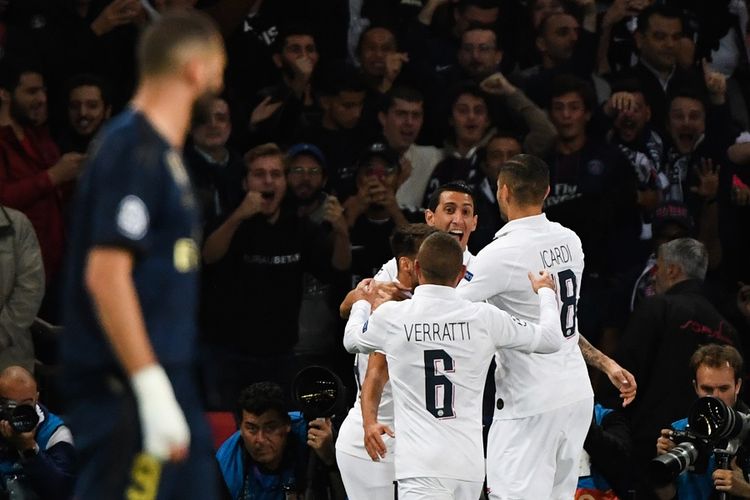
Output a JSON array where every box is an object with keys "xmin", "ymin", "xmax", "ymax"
[{"xmin": 216, "ymin": 382, "xmax": 345, "ymax": 500}]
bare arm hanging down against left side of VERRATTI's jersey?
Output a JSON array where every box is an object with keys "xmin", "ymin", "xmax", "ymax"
[{"xmin": 359, "ymin": 352, "xmax": 394, "ymax": 462}]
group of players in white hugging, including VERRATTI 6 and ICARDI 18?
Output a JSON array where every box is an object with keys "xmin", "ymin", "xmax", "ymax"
[{"xmin": 337, "ymin": 155, "xmax": 636, "ymax": 500}]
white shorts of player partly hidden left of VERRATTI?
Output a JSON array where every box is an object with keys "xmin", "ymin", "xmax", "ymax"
[{"xmin": 336, "ymin": 450, "xmax": 396, "ymax": 500}]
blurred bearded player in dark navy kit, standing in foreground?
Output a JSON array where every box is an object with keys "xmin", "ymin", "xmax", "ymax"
[{"xmin": 62, "ymin": 8, "xmax": 225, "ymax": 500}]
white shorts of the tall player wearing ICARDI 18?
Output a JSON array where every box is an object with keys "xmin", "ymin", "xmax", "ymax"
[{"xmin": 487, "ymin": 398, "xmax": 594, "ymax": 500}]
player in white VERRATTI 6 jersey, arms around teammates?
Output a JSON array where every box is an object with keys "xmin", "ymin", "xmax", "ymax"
[{"xmin": 344, "ymin": 232, "xmax": 563, "ymax": 500}]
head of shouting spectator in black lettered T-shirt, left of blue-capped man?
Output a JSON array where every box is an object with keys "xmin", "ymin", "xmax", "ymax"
[{"xmin": 243, "ymin": 142, "xmax": 286, "ymax": 217}]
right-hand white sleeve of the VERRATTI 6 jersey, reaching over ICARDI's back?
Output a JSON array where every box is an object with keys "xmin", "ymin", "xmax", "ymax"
[{"xmin": 488, "ymin": 288, "xmax": 564, "ymax": 353}]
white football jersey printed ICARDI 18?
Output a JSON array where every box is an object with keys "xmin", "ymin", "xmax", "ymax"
[{"xmin": 458, "ymin": 214, "xmax": 593, "ymax": 419}]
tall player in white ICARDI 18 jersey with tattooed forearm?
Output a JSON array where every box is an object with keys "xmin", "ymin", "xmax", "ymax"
[{"xmin": 458, "ymin": 155, "xmax": 635, "ymax": 500}]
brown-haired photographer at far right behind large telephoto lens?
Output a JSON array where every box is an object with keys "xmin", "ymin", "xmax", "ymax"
[{"xmin": 655, "ymin": 344, "xmax": 750, "ymax": 499}]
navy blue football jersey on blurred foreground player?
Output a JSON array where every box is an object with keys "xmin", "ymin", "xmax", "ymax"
[{"xmin": 61, "ymin": 110, "xmax": 201, "ymax": 369}]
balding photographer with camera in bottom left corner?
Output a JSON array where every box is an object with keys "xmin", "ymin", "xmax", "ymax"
[{"xmin": 0, "ymin": 366, "xmax": 75, "ymax": 500}]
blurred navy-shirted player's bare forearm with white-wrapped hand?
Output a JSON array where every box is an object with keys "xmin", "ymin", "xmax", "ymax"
[{"xmin": 85, "ymin": 247, "xmax": 190, "ymax": 460}]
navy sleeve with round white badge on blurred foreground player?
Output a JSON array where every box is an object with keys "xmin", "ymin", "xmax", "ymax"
[{"xmin": 88, "ymin": 139, "xmax": 166, "ymax": 253}]
